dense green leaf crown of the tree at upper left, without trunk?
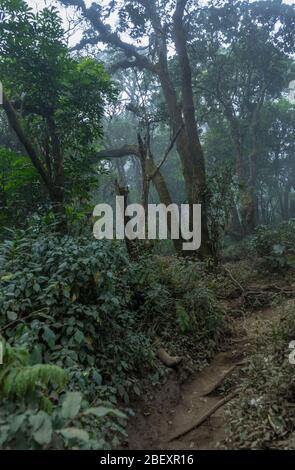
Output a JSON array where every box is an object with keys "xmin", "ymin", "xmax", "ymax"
[{"xmin": 0, "ymin": 2, "xmax": 116, "ymax": 152}]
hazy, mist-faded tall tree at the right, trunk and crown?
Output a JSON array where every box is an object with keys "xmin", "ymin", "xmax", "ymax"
[{"xmin": 191, "ymin": 0, "xmax": 295, "ymax": 235}]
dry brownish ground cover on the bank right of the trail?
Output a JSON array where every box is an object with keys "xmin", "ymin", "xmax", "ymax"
[{"xmin": 227, "ymin": 300, "xmax": 295, "ymax": 449}]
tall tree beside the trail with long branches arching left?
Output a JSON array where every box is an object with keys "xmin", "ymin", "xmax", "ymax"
[{"xmin": 61, "ymin": 0, "xmax": 211, "ymax": 257}]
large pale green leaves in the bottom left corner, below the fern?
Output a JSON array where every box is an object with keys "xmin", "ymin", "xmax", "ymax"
[{"xmin": 0, "ymin": 392, "xmax": 126, "ymax": 450}]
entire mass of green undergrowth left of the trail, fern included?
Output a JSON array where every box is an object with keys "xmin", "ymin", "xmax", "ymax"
[{"xmin": 0, "ymin": 231, "xmax": 225, "ymax": 449}]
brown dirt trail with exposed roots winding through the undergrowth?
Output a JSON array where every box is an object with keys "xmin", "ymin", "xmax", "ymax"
[{"xmin": 128, "ymin": 300, "xmax": 284, "ymax": 450}]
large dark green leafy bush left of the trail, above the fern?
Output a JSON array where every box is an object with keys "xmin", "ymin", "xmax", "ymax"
[{"xmin": 0, "ymin": 232, "xmax": 153, "ymax": 390}]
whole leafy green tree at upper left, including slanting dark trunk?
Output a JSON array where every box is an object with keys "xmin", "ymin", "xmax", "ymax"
[{"xmin": 0, "ymin": 0, "xmax": 115, "ymax": 228}]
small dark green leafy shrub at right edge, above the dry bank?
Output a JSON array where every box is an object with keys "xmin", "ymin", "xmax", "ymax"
[{"xmin": 253, "ymin": 220, "xmax": 295, "ymax": 272}]
